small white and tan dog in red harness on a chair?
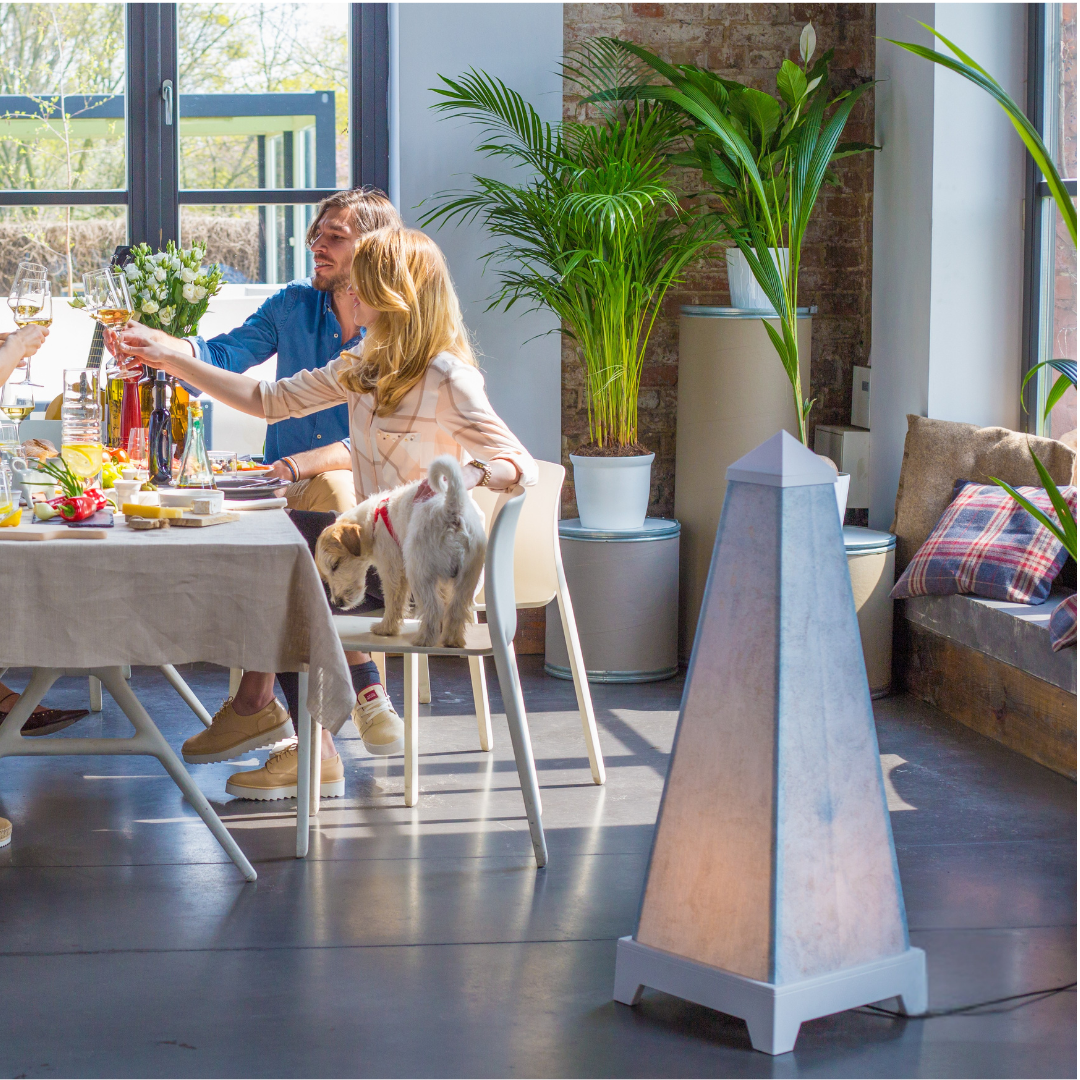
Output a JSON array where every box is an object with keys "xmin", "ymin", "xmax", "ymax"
[{"xmin": 315, "ymin": 455, "xmax": 487, "ymax": 648}]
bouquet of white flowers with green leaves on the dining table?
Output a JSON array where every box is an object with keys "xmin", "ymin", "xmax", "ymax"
[{"xmin": 124, "ymin": 241, "xmax": 221, "ymax": 337}]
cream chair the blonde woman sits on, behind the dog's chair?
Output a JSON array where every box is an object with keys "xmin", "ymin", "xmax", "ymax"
[{"xmin": 374, "ymin": 461, "xmax": 606, "ymax": 784}]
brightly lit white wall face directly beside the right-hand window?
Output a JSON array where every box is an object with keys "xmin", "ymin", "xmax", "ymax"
[{"xmin": 927, "ymin": 3, "xmax": 1027, "ymax": 428}]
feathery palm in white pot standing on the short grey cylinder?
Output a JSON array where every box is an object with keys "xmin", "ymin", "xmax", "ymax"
[{"xmin": 422, "ymin": 40, "xmax": 716, "ymax": 530}]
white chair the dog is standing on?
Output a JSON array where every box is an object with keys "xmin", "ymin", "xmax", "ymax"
[{"xmin": 313, "ymin": 488, "xmax": 548, "ymax": 866}]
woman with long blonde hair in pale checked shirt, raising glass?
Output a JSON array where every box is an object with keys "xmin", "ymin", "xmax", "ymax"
[{"xmin": 121, "ymin": 228, "xmax": 537, "ymax": 799}]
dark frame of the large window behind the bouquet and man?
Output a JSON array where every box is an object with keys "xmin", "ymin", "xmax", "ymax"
[{"xmin": 0, "ymin": 3, "xmax": 390, "ymax": 248}]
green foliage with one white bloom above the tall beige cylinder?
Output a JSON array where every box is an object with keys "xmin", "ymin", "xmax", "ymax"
[{"xmin": 615, "ymin": 25, "xmax": 876, "ymax": 443}]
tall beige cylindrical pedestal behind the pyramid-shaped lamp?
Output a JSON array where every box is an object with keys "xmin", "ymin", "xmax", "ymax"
[{"xmin": 675, "ymin": 306, "xmax": 810, "ymax": 659}]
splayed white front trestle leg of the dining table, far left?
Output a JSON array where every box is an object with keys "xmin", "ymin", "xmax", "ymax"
[{"xmin": 0, "ymin": 665, "xmax": 258, "ymax": 881}]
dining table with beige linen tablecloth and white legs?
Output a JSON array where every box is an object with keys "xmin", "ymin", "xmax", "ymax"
[{"xmin": 0, "ymin": 509, "xmax": 354, "ymax": 881}]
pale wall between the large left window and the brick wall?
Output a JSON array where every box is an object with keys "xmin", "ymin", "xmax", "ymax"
[{"xmin": 391, "ymin": 3, "xmax": 563, "ymax": 461}]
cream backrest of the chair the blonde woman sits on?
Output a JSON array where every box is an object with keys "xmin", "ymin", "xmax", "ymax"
[{"xmin": 472, "ymin": 461, "xmax": 566, "ymax": 607}]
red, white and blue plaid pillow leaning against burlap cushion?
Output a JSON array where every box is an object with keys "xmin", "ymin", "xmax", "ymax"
[{"xmin": 890, "ymin": 480, "xmax": 1077, "ymax": 604}]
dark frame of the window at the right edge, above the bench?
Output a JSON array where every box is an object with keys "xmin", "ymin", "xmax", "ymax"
[{"xmin": 1021, "ymin": 3, "xmax": 1077, "ymax": 435}]
